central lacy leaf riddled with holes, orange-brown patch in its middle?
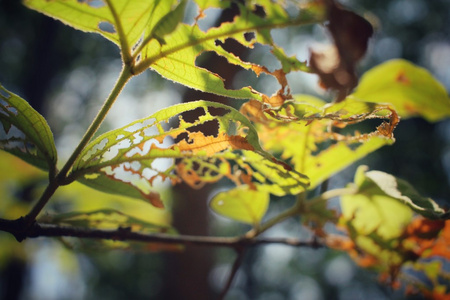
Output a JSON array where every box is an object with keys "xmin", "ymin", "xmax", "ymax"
[{"xmin": 69, "ymin": 101, "xmax": 308, "ymax": 207}]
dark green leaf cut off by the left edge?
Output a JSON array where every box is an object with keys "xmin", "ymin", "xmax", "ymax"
[{"xmin": 0, "ymin": 85, "xmax": 57, "ymax": 170}]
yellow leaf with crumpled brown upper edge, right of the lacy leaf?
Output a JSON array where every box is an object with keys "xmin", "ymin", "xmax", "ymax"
[{"xmin": 241, "ymin": 96, "xmax": 398, "ymax": 188}]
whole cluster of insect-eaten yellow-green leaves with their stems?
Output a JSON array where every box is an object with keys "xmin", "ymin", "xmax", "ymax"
[{"xmin": 0, "ymin": 0, "xmax": 450, "ymax": 294}]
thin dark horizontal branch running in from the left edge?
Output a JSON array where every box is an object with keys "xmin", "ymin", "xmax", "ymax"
[{"xmin": 0, "ymin": 218, "xmax": 323, "ymax": 249}]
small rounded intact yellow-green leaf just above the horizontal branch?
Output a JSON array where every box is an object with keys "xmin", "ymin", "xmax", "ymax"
[{"xmin": 209, "ymin": 186, "xmax": 270, "ymax": 225}]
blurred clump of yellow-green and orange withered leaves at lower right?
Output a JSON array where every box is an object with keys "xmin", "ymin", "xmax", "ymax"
[{"xmin": 340, "ymin": 166, "xmax": 449, "ymax": 285}]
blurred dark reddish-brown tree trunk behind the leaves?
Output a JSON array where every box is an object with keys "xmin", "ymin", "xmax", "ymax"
[{"xmin": 162, "ymin": 5, "xmax": 245, "ymax": 300}]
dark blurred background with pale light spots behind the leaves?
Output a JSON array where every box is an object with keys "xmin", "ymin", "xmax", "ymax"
[{"xmin": 0, "ymin": 0, "xmax": 450, "ymax": 300}]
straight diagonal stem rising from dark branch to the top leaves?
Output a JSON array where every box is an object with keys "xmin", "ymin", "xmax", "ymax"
[{"xmin": 24, "ymin": 65, "xmax": 133, "ymax": 226}]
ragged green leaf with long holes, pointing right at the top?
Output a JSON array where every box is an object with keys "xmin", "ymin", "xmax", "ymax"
[{"xmin": 135, "ymin": 1, "xmax": 324, "ymax": 103}]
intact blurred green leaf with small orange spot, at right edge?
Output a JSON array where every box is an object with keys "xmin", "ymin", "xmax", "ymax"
[{"xmin": 350, "ymin": 59, "xmax": 450, "ymax": 122}]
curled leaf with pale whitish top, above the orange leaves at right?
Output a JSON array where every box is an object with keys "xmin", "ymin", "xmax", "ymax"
[{"xmin": 356, "ymin": 165, "xmax": 450, "ymax": 219}]
